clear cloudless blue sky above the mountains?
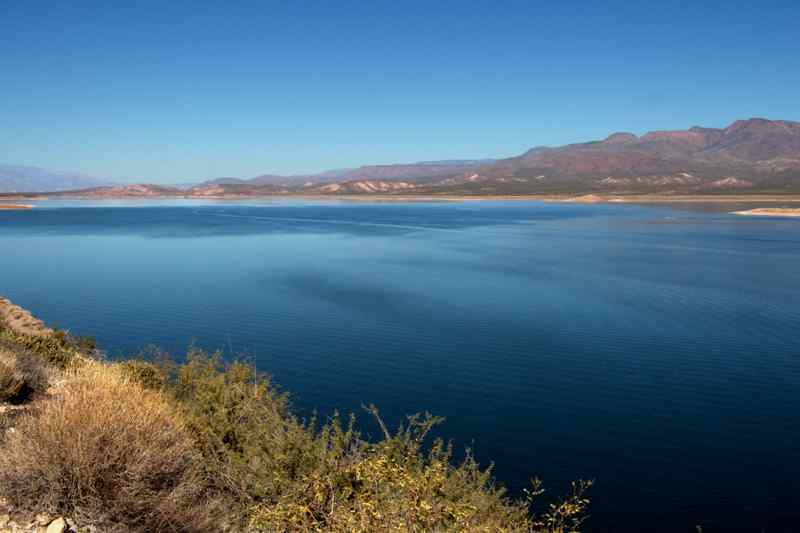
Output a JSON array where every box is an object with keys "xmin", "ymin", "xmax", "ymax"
[{"xmin": 0, "ymin": 0, "xmax": 800, "ymax": 183}]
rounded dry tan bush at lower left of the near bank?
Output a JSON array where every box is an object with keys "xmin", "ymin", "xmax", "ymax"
[{"xmin": 0, "ymin": 363, "xmax": 219, "ymax": 531}]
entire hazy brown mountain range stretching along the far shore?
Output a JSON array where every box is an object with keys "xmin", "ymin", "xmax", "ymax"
[{"xmin": 6, "ymin": 118, "xmax": 800, "ymax": 197}]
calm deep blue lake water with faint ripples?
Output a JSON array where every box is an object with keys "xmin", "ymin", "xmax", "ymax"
[{"xmin": 0, "ymin": 202, "xmax": 800, "ymax": 532}]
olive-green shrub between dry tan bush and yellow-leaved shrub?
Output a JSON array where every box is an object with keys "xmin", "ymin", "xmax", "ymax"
[{"xmin": 168, "ymin": 349, "xmax": 324, "ymax": 508}]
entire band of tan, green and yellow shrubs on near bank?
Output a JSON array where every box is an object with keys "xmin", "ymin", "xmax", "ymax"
[{"xmin": 0, "ymin": 310, "xmax": 590, "ymax": 533}]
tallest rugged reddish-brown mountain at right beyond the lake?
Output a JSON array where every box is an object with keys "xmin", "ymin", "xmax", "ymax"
[{"xmin": 460, "ymin": 118, "xmax": 800, "ymax": 192}]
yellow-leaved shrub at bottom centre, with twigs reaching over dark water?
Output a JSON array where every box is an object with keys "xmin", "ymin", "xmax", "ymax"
[{"xmin": 250, "ymin": 406, "xmax": 588, "ymax": 533}]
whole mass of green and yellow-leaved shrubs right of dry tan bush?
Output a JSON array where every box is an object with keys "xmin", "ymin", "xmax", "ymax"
[{"xmin": 156, "ymin": 349, "xmax": 587, "ymax": 533}]
